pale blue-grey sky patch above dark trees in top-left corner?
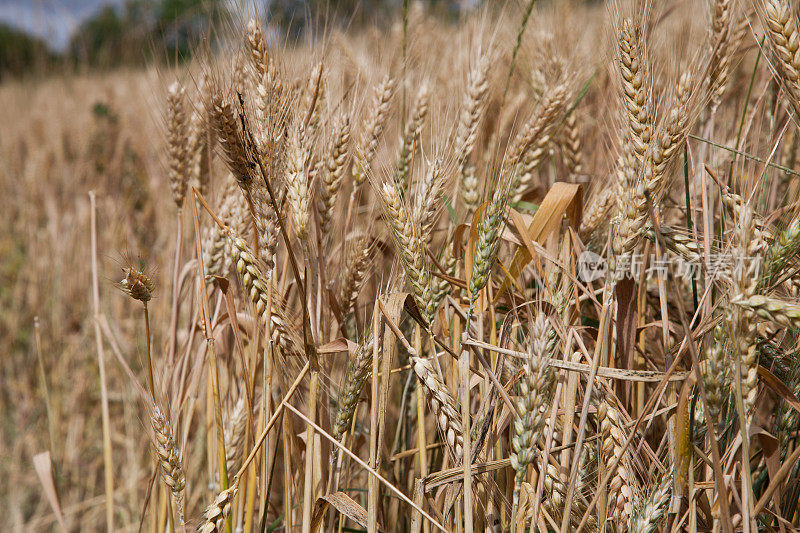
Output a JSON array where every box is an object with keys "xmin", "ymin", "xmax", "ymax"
[{"xmin": 0, "ymin": 0, "xmax": 123, "ymax": 50}]
